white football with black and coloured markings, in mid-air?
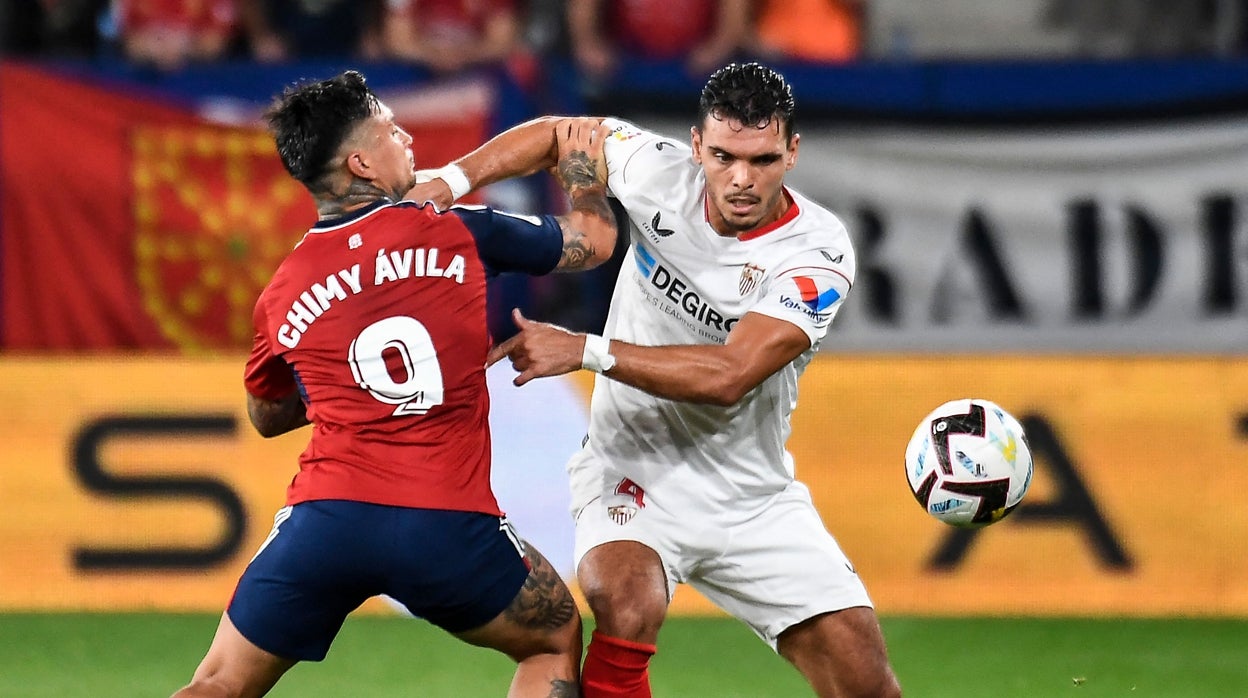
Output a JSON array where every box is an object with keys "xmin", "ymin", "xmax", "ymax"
[{"xmin": 906, "ymin": 400, "xmax": 1032, "ymax": 528}]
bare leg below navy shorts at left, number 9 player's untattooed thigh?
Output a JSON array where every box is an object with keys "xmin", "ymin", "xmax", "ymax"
[{"xmin": 180, "ymin": 614, "xmax": 296, "ymax": 697}]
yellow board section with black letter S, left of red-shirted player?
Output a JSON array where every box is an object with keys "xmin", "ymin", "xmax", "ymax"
[{"xmin": 0, "ymin": 357, "xmax": 294, "ymax": 609}]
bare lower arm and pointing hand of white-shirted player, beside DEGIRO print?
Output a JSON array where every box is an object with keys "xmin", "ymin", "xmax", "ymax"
[{"xmin": 487, "ymin": 310, "xmax": 810, "ymax": 407}]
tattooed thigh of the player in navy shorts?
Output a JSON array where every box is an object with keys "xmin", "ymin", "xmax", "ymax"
[{"xmin": 453, "ymin": 544, "xmax": 582, "ymax": 661}]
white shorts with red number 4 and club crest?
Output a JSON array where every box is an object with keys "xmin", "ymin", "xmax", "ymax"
[{"xmin": 575, "ymin": 482, "xmax": 871, "ymax": 649}]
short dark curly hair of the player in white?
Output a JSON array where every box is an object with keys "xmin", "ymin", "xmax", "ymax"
[{"xmin": 698, "ymin": 62, "xmax": 795, "ymax": 139}]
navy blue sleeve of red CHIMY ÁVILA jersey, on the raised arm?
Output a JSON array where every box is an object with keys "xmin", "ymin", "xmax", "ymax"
[{"xmin": 451, "ymin": 206, "xmax": 563, "ymax": 276}]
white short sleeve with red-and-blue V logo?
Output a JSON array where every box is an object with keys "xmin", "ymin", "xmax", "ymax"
[{"xmin": 750, "ymin": 251, "xmax": 852, "ymax": 346}]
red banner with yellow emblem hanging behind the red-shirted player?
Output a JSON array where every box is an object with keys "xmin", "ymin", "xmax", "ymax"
[{"xmin": 0, "ymin": 65, "xmax": 487, "ymax": 353}]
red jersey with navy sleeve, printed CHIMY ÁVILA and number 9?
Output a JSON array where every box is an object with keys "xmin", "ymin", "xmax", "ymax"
[{"xmin": 245, "ymin": 202, "xmax": 563, "ymax": 514}]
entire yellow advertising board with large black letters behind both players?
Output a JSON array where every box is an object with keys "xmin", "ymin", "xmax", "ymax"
[{"xmin": 0, "ymin": 355, "xmax": 1248, "ymax": 616}]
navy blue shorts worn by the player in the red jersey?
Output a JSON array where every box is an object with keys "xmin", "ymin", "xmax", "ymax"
[{"xmin": 227, "ymin": 499, "xmax": 529, "ymax": 661}]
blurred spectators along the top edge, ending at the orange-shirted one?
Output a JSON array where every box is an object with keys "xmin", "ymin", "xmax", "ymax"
[{"xmin": 0, "ymin": 0, "xmax": 862, "ymax": 73}]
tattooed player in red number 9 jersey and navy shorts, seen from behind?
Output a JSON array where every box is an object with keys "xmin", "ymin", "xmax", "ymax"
[{"xmin": 176, "ymin": 71, "xmax": 615, "ymax": 697}]
